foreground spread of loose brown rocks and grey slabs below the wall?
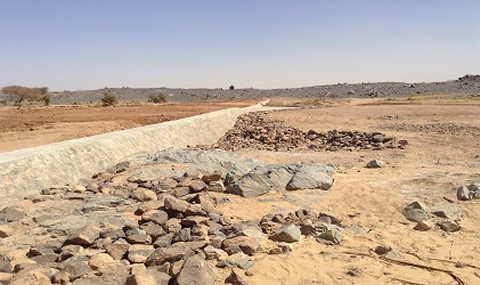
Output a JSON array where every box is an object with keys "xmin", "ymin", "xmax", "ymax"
[{"xmin": 0, "ymin": 150, "xmax": 343, "ymax": 285}]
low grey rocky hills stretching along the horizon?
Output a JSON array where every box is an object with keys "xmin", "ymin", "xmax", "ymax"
[{"xmin": 0, "ymin": 75, "xmax": 480, "ymax": 105}]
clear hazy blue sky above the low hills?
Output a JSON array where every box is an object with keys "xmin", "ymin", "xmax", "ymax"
[{"xmin": 0, "ymin": 0, "xmax": 480, "ymax": 90}]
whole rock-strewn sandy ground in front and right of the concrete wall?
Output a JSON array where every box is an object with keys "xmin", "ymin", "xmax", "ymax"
[{"xmin": 0, "ymin": 100, "xmax": 480, "ymax": 284}]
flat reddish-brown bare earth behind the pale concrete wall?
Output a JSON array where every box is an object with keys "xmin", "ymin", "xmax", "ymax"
[{"xmin": 0, "ymin": 100, "xmax": 259, "ymax": 152}]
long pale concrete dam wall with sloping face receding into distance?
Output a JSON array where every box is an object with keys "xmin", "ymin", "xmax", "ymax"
[{"xmin": 0, "ymin": 104, "xmax": 278, "ymax": 204}]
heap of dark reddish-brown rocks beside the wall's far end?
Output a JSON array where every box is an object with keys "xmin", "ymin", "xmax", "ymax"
[{"xmin": 200, "ymin": 113, "xmax": 408, "ymax": 151}]
